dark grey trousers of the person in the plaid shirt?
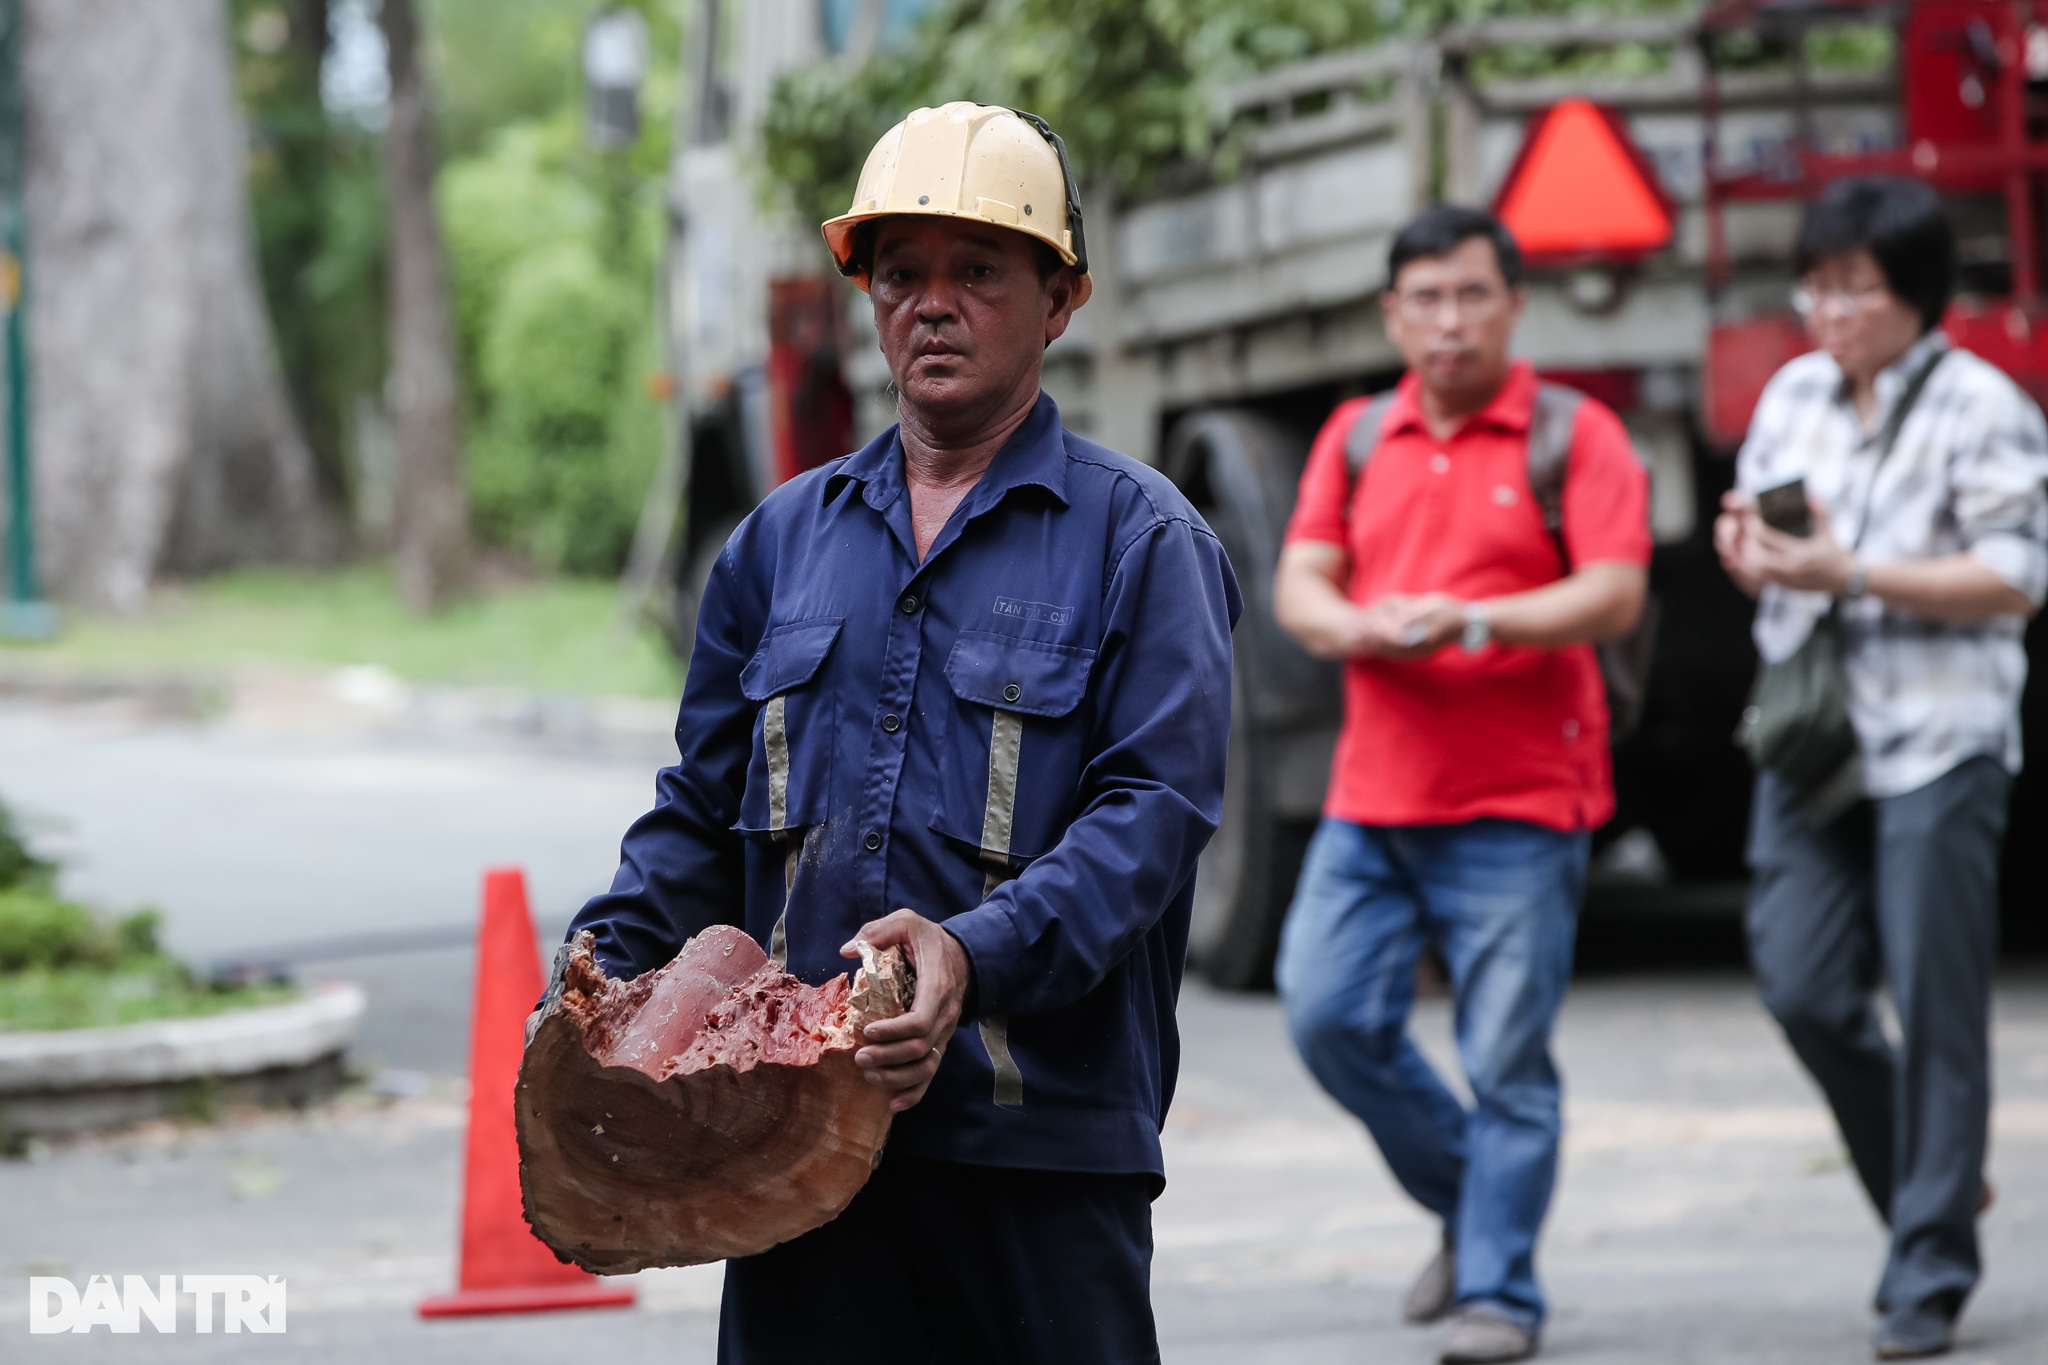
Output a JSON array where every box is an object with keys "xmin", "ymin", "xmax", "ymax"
[{"xmin": 1749, "ymin": 757, "xmax": 2011, "ymax": 1310}]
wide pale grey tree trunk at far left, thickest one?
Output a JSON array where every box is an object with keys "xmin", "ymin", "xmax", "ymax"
[{"xmin": 23, "ymin": 0, "xmax": 332, "ymax": 608}]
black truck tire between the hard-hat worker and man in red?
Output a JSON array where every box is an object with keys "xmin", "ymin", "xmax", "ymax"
[{"xmin": 1163, "ymin": 409, "xmax": 1341, "ymax": 990}]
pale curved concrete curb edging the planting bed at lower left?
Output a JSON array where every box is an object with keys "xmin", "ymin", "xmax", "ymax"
[{"xmin": 0, "ymin": 982, "xmax": 367, "ymax": 1099}]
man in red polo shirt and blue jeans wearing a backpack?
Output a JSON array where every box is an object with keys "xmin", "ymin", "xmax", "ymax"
[{"xmin": 1274, "ymin": 207, "xmax": 1651, "ymax": 1363}]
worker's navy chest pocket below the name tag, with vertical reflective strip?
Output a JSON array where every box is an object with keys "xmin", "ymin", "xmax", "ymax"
[{"xmin": 932, "ymin": 630, "xmax": 1096, "ymax": 874}]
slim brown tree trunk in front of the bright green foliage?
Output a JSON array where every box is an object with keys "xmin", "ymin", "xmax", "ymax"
[{"xmin": 383, "ymin": 0, "xmax": 469, "ymax": 612}]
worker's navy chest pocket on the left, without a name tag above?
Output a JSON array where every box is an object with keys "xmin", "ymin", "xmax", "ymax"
[{"xmin": 735, "ymin": 616, "xmax": 842, "ymax": 835}]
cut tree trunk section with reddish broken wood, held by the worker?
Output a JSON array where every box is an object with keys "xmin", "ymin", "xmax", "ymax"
[{"xmin": 516, "ymin": 925, "xmax": 913, "ymax": 1275}]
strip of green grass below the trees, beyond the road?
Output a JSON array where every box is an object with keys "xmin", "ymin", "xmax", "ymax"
[{"xmin": 0, "ymin": 567, "xmax": 682, "ymax": 700}]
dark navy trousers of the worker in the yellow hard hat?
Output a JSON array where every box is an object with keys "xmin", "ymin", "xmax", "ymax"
[{"xmin": 719, "ymin": 1154, "xmax": 1159, "ymax": 1365}]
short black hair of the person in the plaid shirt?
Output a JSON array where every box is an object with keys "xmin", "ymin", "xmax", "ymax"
[{"xmin": 1794, "ymin": 176, "xmax": 1956, "ymax": 332}]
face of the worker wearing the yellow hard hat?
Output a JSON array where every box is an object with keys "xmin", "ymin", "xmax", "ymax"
[{"xmin": 868, "ymin": 217, "xmax": 1075, "ymax": 430}]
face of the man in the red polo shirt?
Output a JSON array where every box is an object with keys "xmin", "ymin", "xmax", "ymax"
[{"xmin": 1380, "ymin": 237, "xmax": 1522, "ymax": 399}]
